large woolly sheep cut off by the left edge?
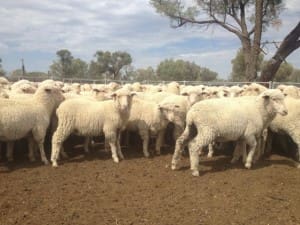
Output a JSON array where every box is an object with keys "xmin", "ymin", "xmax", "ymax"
[{"xmin": 0, "ymin": 86, "xmax": 64, "ymax": 164}]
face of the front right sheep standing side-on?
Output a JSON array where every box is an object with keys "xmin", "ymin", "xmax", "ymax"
[{"xmin": 261, "ymin": 90, "xmax": 288, "ymax": 116}]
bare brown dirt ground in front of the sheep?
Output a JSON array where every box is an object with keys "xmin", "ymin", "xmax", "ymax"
[{"xmin": 0, "ymin": 137, "xmax": 300, "ymax": 225}]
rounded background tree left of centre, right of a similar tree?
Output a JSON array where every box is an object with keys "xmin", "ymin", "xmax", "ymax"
[{"xmin": 95, "ymin": 51, "xmax": 132, "ymax": 80}]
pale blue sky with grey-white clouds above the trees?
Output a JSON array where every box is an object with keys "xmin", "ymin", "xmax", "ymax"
[{"xmin": 0, "ymin": 0, "xmax": 300, "ymax": 78}]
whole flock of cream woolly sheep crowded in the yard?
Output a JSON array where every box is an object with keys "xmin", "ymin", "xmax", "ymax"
[{"xmin": 0, "ymin": 77, "xmax": 300, "ymax": 176}]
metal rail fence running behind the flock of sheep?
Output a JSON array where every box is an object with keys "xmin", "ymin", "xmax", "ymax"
[{"xmin": 8, "ymin": 76, "xmax": 300, "ymax": 88}]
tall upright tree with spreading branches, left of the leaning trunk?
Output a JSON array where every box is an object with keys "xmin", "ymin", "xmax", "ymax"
[{"xmin": 150, "ymin": 0, "xmax": 283, "ymax": 81}]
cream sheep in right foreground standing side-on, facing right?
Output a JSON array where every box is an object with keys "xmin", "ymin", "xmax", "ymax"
[{"xmin": 172, "ymin": 90, "xmax": 288, "ymax": 176}]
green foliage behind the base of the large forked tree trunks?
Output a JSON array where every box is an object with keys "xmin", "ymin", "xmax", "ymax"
[{"xmin": 229, "ymin": 48, "xmax": 264, "ymax": 81}]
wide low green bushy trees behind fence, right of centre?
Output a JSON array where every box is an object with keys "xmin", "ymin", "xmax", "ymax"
[{"xmin": 156, "ymin": 59, "xmax": 218, "ymax": 81}]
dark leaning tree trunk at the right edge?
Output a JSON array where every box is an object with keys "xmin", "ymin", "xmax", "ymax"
[{"xmin": 260, "ymin": 22, "xmax": 300, "ymax": 82}]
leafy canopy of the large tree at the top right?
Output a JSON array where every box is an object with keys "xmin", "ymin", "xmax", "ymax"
[{"xmin": 150, "ymin": 0, "xmax": 284, "ymax": 28}]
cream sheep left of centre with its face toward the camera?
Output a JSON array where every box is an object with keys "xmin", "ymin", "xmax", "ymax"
[{"xmin": 51, "ymin": 89, "xmax": 134, "ymax": 167}]
